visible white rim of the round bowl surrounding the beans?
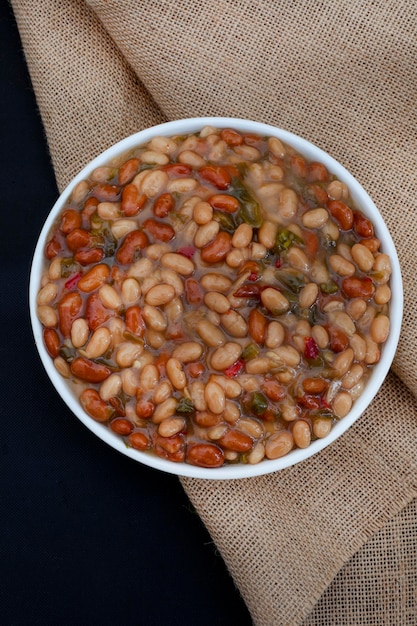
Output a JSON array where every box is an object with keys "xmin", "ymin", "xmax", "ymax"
[{"xmin": 30, "ymin": 117, "xmax": 403, "ymax": 480}]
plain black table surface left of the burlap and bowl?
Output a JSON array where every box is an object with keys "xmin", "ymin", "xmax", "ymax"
[{"xmin": 0, "ymin": 0, "xmax": 251, "ymax": 626}]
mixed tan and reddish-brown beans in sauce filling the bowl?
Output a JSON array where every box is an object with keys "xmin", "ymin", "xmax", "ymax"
[{"xmin": 37, "ymin": 126, "xmax": 391, "ymax": 468}]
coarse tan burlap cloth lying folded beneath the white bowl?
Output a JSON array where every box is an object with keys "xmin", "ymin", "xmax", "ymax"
[{"xmin": 12, "ymin": 0, "xmax": 417, "ymax": 626}]
